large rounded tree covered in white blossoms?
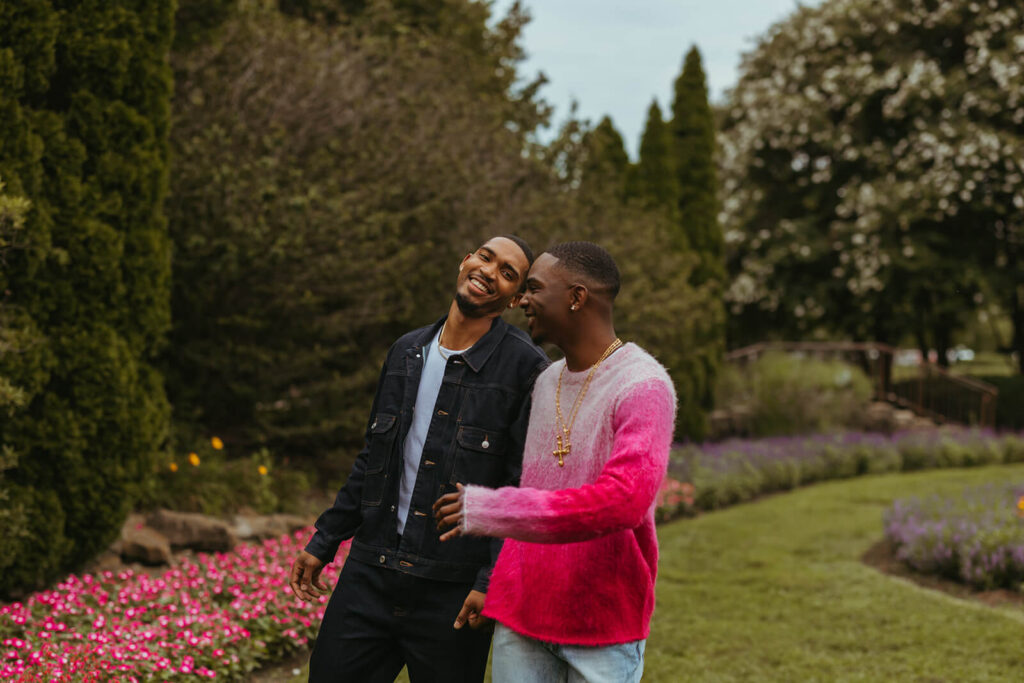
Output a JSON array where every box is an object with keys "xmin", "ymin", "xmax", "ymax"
[{"xmin": 720, "ymin": 0, "xmax": 1024, "ymax": 368}]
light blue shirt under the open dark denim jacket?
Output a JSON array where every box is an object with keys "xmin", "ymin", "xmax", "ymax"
[{"xmin": 397, "ymin": 330, "xmax": 465, "ymax": 533}]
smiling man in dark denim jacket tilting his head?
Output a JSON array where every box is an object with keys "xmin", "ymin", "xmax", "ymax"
[{"xmin": 291, "ymin": 236, "xmax": 548, "ymax": 683}]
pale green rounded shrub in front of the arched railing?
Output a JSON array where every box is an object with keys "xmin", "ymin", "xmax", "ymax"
[{"xmin": 716, "ymin": 352, "xmax": 871, "ymax": 436}]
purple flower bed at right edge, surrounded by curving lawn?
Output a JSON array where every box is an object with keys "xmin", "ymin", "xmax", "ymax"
[{"xmin": 885, "ymin": 483, "xmax": 1024, "ymax": 590}]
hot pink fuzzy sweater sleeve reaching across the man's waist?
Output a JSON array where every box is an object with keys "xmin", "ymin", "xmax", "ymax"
[{"xmin": 462, "ymin": 381, "xmax": 676, "ymax": 543}]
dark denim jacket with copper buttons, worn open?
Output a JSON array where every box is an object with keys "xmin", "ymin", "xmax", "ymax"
[{"xmin": 306, "ymin": 317, "xmax": 549, "ymax": 592}]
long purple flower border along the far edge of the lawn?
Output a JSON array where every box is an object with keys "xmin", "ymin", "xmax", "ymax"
[{"xmin": 659, "ymin": 428, "xmax": 1024, "ymax": 511}]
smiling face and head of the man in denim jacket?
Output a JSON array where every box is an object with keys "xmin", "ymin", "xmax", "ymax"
[{"xmin": 455, "ymin": 238, "xmax": 529, "ymax": 316}]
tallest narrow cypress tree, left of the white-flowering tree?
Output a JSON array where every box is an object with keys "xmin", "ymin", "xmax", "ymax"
[{"xmin": 672, "ymin": 46, "xmax": 725, "ymax": 437}]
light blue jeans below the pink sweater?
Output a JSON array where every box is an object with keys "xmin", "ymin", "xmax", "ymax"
[{"xmin": 490, "ymin": 624, "xmax": 647, "ymax": 683}]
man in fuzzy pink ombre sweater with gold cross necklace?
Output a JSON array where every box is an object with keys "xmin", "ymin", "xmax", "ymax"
[{"xmin": 434, "ymin": 242, "xmax": 676, "ymax": 683}]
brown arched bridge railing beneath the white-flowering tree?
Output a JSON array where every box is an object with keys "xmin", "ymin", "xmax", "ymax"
[{"xmin": 725, "ymin": 342, "xmax": 998, "ymax": 427}]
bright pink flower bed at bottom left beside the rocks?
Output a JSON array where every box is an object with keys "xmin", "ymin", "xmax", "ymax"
[{"xmin": 0, "ymin": 529, "xmax": 346, "ymax": 682}]
